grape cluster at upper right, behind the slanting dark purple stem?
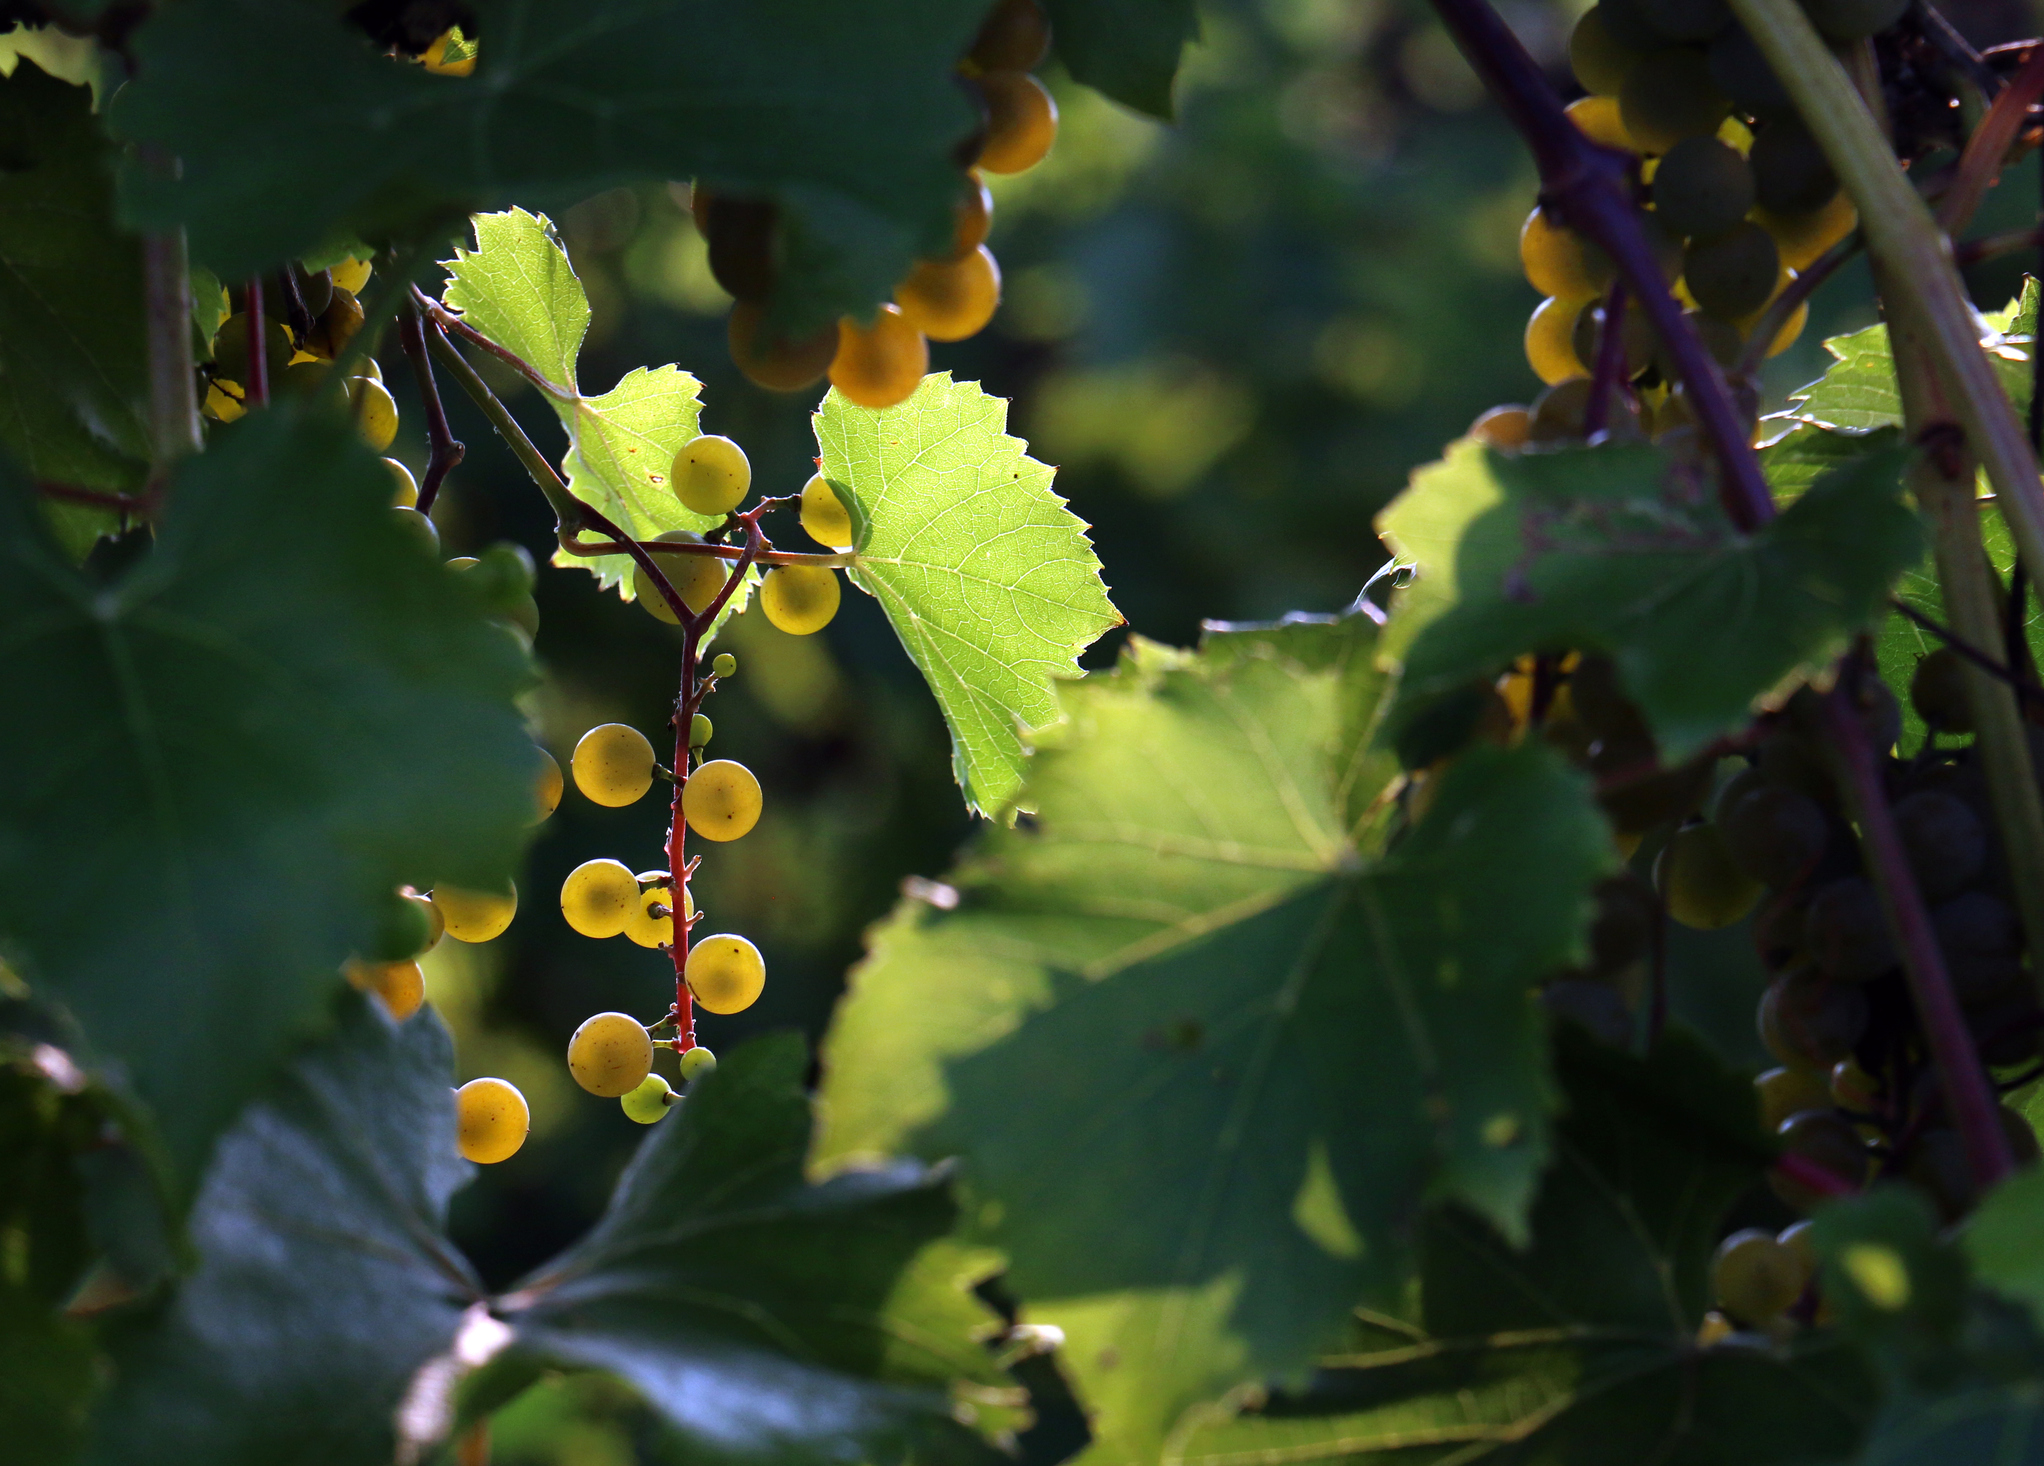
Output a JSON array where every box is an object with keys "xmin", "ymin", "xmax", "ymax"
[{"xmin": 1472, "ymin": 0, "xmax": 1872, "ymax": 450}]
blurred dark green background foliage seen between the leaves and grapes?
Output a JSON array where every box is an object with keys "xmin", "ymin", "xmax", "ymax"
[{"xmin": 359, "ymin": 0, "xmax": 2038, "ymax": 1466}]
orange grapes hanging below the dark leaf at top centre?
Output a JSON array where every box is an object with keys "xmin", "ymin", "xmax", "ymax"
[{"xmin": 689, "ymin": 0, "xmax": 1057, "ymax": 407}]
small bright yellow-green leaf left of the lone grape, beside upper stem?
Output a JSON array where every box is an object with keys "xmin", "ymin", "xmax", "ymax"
[{"xmin": 446, "ymin": 209, "xmax": 715, "ymax": 601}]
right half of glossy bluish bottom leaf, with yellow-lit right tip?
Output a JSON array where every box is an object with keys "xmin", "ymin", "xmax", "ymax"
[{"xmin": 478, "ymin": 1035, "xmax": 1002, "ymax": 1466}]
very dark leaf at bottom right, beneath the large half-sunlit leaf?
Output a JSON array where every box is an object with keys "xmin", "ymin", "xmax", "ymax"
[{"xmin": 1173, "ymin": 1028, "xmax": 1872, "ymax": 1466}]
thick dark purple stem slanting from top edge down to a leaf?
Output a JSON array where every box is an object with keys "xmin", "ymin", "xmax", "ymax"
[{"xmin": 1433, "ymin": 0, "xmax": 1774, "ymax": 532}]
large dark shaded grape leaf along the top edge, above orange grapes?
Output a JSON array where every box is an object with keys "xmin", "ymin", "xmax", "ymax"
[{"xmin": 110, "ymin": 0, "xmax": 985, "ymax": 329}]
